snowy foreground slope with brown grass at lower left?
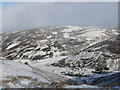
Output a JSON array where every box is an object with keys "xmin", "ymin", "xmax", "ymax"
[{"xmin": 0, "ymin": 60, "xmax": 65, "ymax": 88}]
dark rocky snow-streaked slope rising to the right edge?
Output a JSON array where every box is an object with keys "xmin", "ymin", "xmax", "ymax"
[{"xmin": 56, "ymin": 35, "xmax": 120, "ymax": 71}]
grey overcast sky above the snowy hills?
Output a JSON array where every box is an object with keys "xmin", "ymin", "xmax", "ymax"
[{"xmin": 2, "ymin": 2, "xmax": 118, "ymax": 32}]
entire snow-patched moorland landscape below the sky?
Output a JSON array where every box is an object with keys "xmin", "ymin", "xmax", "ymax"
[{"xmin": 0, "ymin": 26, "xmax": 120, "ymax": 88}]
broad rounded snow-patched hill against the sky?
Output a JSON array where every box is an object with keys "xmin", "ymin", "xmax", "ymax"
[{"xmin": 2, "ymin": 26, "xmax": 118, "ymax": 60}]
